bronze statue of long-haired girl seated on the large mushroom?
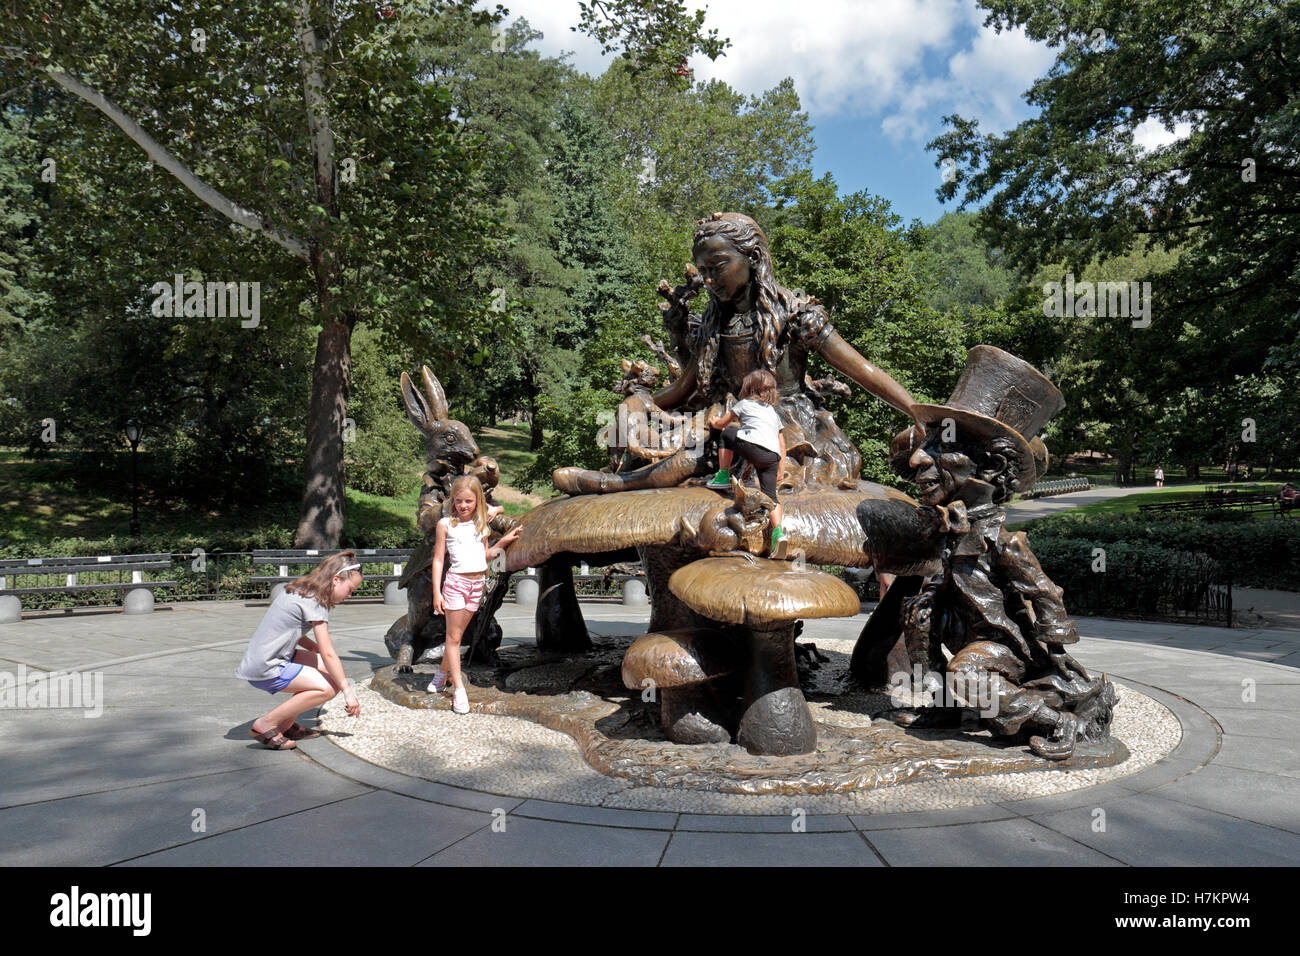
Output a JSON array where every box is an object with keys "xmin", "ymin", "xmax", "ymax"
[{"xmin": 554, "ymin": 212, "xmax": 913, "ymax": 494}]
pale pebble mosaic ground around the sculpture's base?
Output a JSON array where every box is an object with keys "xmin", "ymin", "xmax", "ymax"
[{"xmin": 321, "ymin": 639, "xmax": 1182, "ymax": 814}]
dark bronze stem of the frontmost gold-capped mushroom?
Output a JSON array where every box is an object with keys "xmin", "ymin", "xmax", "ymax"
[{"xmin": 736, "ymin": 622, "xmax": 816, "ymax": 757}]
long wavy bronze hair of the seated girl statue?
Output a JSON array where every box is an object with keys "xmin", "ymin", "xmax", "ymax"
[{"xmin": 692, "ymin": 212, "xmax": 800, "ymax": 393}]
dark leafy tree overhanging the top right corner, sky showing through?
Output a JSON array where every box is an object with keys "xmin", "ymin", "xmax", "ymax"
[{"xmin": 931, "ymin": 0, "xmax": 1300, "ymax": 418}]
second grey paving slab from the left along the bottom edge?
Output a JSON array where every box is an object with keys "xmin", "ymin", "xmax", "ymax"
[{"xmin": 118, "ymin": 790, "xmax": 478, "ymax": 866}]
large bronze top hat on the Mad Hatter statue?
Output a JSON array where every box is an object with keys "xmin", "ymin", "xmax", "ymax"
[{"xmin": 911, "ymin": 345, "xmax": 1065, "ymax": 492}]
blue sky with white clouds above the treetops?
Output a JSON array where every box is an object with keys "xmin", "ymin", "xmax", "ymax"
[{"xmin": 488, "ymin": 0, "xmax": 1054, "ymax": 222}]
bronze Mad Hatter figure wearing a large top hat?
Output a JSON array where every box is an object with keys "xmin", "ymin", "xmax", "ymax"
[{"xmin": 853, "ymin": 346, "xmax": 1117, "ymax": 760}]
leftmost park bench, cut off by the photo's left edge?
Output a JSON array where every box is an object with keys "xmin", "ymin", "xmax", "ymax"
[{"xmin": 0, "ymin": 554, "xmax": 177, "ymax": 623}]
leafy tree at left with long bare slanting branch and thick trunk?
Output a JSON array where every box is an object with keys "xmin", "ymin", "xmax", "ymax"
[{"xmin": 0, "ymin": 0, "xmax": 490, "ymax": 548}]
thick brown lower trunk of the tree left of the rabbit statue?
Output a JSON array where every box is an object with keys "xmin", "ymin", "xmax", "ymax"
[{"xmin": 294, "ymin": 319, "xmax": 352, "ymax": 549}]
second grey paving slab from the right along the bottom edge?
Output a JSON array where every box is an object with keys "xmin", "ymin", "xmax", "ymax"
[{"xmin": 871, "ymin": 818, "xmax": 1118, "ymax": 866}]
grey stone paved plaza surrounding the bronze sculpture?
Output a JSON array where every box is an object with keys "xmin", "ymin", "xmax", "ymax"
[{"xmin": 0, "ymin": 596, "xmax": 1300, "ymax": 866}]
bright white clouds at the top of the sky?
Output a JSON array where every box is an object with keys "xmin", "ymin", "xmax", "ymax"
[{"xmin": 488, "ymin": 0, "xmax": 1053, "ymax": 142}]
